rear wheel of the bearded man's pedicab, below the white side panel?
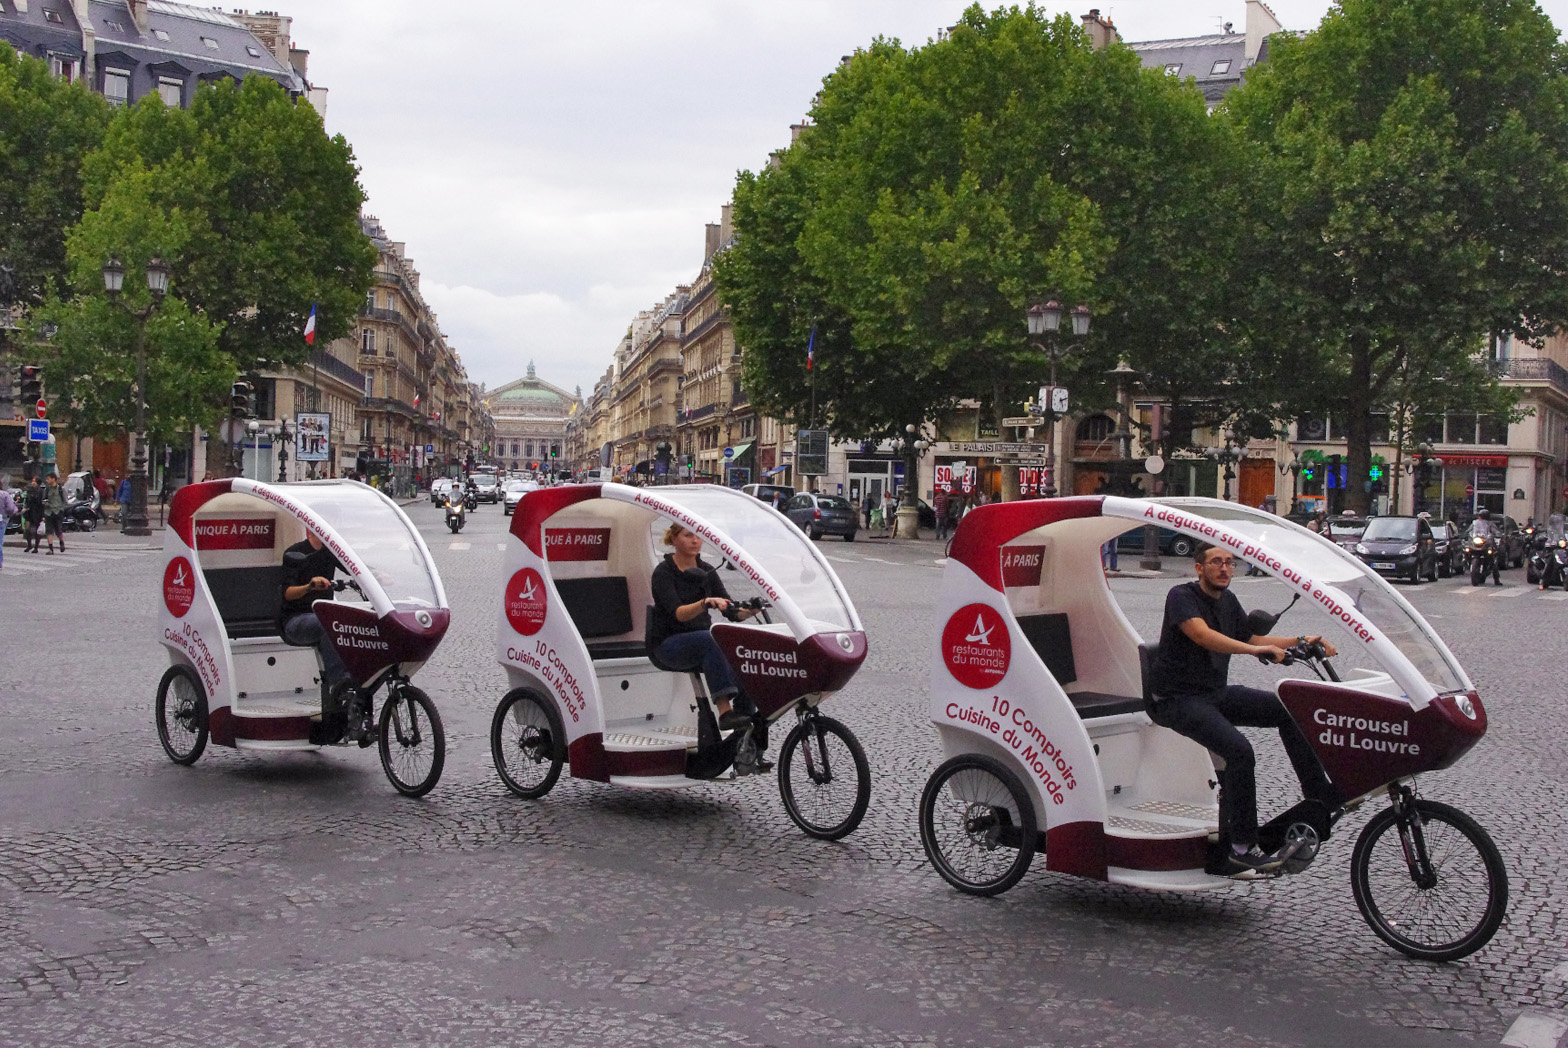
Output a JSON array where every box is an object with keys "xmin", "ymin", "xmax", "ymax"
[{"xmin": 920, "ymin": 753, "xmax": 1038, "ymax": 896}]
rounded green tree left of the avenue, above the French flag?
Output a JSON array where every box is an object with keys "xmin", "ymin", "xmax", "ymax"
[{"xmin": 83, "ymin": 77, "xmax": 376, "ymax": 372}]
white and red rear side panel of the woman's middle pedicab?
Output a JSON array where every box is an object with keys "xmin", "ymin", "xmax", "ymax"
[{"xmin": 495, "ymin": 485, "xmax": 610, "ymax": 783}]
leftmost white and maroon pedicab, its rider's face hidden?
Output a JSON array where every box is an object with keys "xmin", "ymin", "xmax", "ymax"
[{"xmin": 155, "ymin": 479, "xmax": 450, "ymax": 797}]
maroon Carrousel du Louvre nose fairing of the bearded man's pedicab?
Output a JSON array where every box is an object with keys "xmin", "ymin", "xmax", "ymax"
[{"xmin": 1279, "ymin": 681, "xmax": 1486, "ymax": 799}]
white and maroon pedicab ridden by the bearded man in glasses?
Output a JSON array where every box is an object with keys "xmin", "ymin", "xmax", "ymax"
[{"xmin": 919, "ymin": 496, "xmax": 1508, "ymax": 960}]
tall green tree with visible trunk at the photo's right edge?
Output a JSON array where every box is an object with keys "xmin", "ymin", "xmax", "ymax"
[{"xmin": 1226, "ymin": 0, "xmax": 1568, "ymax": 510}]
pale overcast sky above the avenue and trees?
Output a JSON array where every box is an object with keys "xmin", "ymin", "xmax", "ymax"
[{"xmin": 294, "ymin": 0, "xmax": 1568, "ymax": 392}]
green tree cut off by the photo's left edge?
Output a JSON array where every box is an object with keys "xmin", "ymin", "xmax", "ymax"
[{"xmin": 0, "ymin": 41, "xmax": 110, "ymax": 323}]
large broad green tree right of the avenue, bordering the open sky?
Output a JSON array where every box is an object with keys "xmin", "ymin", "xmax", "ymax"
[{"xmin": 715, "ymin": 6, "xmax": 1248, "ymax": 454}]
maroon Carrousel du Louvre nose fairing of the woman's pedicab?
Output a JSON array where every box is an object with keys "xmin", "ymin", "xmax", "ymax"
[{"xmin": 712, "ymin": 623, "xmax": 866, "ymax": 717}]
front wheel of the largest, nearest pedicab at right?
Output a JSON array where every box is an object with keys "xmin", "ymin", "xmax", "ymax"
[{"xmin": 1350, "ymin": 799, "xmax": 1508, "ymax": 960}]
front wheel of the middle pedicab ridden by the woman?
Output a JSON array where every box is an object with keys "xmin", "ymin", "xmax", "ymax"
[{"xmin": 779, "ymin": 711, "xmax": 872, "ymax": 841}]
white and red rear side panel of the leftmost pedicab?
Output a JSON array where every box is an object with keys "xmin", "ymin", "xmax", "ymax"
[{"xmin": 158, "ymin": 480, "xmax": 235, "ymax": 747}]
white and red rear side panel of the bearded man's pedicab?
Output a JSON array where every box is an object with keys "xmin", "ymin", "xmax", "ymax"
[{"xmin": 931, "ymin": 499, "xmax": 1110, "ymax": 880}]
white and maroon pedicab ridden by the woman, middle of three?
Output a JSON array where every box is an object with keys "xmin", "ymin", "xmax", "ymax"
[{"xmin": 491, "ymin": 483, "xmax": 870, "ymax": 841}]
